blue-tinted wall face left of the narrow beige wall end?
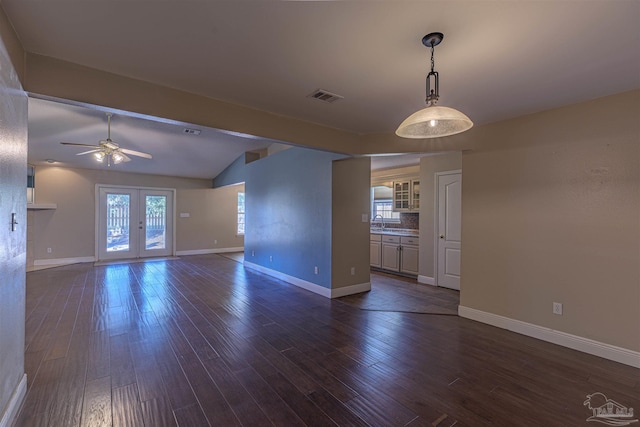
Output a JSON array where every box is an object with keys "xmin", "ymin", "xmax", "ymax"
[{"xmin": 245, "ymin": 148, "xmax": 347, "ymax": 288}]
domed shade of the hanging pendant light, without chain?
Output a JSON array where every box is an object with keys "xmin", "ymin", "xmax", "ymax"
[{"xmin": 396, "ymin": 105, "xmax": 473, "ymax": 139}]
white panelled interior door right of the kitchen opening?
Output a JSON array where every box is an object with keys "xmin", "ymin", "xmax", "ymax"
[{"xmin": 436, "ymin": 172, "xmax": 462, "ymax": 290}]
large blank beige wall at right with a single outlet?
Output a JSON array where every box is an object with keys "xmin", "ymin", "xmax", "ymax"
[{"xmin": 461, "ymin": 91, "xmax": 640, "ymax": 351}]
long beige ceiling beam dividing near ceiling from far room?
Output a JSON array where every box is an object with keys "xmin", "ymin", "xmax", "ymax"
[{"xmin": 23, "ymin": 52, "xmax": 361, "ymax": 154}]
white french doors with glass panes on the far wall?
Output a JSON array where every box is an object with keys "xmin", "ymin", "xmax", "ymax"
[{"xmin": 96, "ymin": 186, "xmax": 174, "ymax": 261}]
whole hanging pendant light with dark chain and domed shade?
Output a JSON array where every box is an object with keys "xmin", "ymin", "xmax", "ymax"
[{"xmin": 396, "ymin": 33, "xmax": 473, "ymax": 139}]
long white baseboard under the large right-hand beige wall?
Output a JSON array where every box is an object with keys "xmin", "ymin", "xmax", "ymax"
[{"xmin": 458, "ymin": 305, "xmax": 640, "ymax": 368}]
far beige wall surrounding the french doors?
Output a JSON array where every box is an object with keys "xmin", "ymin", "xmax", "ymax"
[{"xmin": 30, "ymin": 166, "xmax": 242, "ymax": 260}]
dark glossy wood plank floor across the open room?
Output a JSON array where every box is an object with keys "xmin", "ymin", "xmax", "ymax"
[{"xmin": 17, "ymin": 255, "xmax": 640, "ymax": 427}]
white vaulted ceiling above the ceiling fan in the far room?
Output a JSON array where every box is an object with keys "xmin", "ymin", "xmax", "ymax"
[{"xmin": 28, "ymin": 98, "xmax": 274, "ymax": 178}]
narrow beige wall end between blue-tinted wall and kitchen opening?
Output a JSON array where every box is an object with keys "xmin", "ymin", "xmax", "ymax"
[{"xmin": 331, "ymin": 157, "xmax": 371, "ymax": 289}]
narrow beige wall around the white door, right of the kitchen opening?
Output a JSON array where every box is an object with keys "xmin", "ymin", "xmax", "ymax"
[{"xmin": 419, "ymin": 152, "xmax": 464, "ymax": 280}]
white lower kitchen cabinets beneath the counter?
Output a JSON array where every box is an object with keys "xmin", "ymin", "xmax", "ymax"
[{"xmin": 370, "ymin": 234, "xmax": 419, "ymax": 276}]
